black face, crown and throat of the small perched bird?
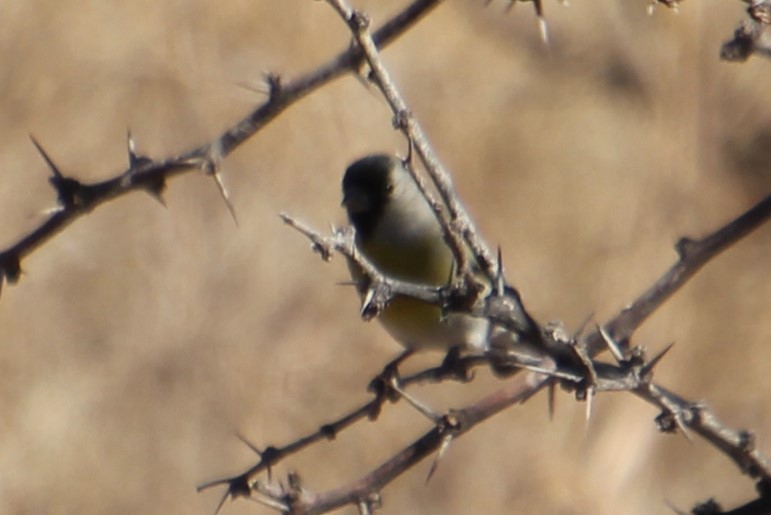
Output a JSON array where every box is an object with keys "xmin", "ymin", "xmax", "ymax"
[{"xmin": 343, "ymin": 154, "xmax": 399, "ymax": 239}]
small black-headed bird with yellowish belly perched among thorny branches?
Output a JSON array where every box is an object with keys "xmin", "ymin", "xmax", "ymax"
[{"xmin": 343, "ymin": 154, "xmax": 490, "ymax": 352}]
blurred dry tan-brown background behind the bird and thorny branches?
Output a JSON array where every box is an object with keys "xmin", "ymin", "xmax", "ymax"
[{"xmin": 0, "ymin": 0, "xmax": 771, "ymax": 515}]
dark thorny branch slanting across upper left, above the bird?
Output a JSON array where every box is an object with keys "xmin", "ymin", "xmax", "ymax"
[{"xmin": 0, "ymin": 0, "xmax": 440, "ymax": 298}]
